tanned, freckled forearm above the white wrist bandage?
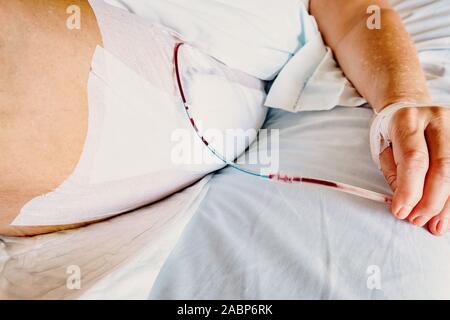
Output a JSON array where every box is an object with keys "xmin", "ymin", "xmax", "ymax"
[{"xmin": 311, "ymin": 0, "xmax": 431, "ymax": 111}]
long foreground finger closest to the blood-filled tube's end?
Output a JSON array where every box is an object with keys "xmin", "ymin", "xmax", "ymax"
[{"xmin": 390, "ymin": 108, "xmax": 429, "ymax": 219}]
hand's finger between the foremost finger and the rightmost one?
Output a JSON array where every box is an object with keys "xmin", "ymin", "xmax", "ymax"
[{"xmin": 409, "ymin": 110, "xmax": 450, "ymax": 227}]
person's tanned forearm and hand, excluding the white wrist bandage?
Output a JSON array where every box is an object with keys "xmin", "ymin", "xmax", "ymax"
[{"xmin": 311, "ymin": 0, "xmax": 450, "ymax": 234}]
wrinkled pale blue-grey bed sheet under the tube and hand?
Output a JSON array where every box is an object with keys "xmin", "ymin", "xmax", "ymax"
[{"xmin": 150, "ymin": 108, "xmax": 450, "ymax": 299}]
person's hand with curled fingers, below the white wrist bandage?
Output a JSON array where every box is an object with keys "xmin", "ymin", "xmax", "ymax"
[{"xmin": 380, "ymin": 107, "xmax": 450, "ymax": 235}]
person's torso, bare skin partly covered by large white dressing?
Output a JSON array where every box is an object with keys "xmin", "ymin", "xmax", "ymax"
[{"xmin": 0, "ymin": 0, "xmax": 265, "ymax": 234}]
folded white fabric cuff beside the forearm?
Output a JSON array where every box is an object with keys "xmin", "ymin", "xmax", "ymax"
[{"xmin": 265, "ymin": 13, "xmax": 366, "ymax": 112}]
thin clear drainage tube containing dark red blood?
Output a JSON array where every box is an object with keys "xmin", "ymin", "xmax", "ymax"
[{"xmin": 173, "ymin": 42, "xmax": 392, "ymax": 203}]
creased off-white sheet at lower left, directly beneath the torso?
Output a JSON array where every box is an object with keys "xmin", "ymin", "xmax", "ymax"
[{"xmin": 0, "ymin": 176, "xmax": 210, "ymax": 300}]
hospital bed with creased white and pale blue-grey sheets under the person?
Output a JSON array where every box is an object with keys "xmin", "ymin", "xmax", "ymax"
[{"xmin": 0, "ymin": 0, "xmax": 450, "ymax": 299}]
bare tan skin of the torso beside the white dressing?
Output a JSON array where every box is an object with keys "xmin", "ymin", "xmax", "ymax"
[{"xmin": 0, "ymin": 0, "xmax": 101, "ymax": 236}]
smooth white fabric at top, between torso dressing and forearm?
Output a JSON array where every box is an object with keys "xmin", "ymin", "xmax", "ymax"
[{"xmin": 108, "ymin": 0, "xmax": 311, "ymax": 80}]
